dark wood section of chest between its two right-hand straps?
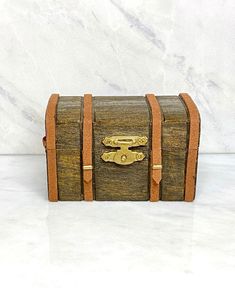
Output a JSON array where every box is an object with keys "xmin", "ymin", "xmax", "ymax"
[{"xmin": 158, "ymin": 96, "xmax": 189, "ymax": 201}]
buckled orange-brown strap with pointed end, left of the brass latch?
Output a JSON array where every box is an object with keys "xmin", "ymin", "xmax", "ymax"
[{"xmin": 82, "ymin": 94, "xmax": 93, "ymax": 201}]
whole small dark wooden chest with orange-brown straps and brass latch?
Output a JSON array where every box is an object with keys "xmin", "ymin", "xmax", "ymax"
[{"xmin": 43, "ymin": 93, "xmax": 200, "ymax": 201}]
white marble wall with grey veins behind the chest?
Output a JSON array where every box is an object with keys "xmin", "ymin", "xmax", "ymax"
[{"xmin": 0, "ymin": 0, "xmax": 235, "ymax": 154}]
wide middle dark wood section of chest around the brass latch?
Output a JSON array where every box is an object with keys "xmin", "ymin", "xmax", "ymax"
[{"xmin": 93, "ymin": 96, "xmax": 151, "ymax": 200}]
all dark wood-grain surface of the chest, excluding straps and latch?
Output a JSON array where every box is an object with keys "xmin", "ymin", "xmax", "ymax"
[{"xmin": 56, "ymin": 96, "xmax": 193, "ymax": 201}]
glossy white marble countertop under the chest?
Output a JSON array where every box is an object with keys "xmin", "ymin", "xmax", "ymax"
[{"xmin": 0, "ymin": 154, "xmax": 235, "ymax": 287}]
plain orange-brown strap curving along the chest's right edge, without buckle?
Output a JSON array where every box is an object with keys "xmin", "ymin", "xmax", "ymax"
[{"xmin": 179, "ymin": 93, "xmax": 200, "ymax": 202}]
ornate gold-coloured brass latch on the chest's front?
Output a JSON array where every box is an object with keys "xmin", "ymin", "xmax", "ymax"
[{"xmin": 101, "ymin": 136, "xmax": 148, "ymax": 165}]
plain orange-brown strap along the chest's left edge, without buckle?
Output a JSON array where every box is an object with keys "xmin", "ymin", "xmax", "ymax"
[{"xmin": 43, "ymin": 94, "xmax": 59, "ymax": 201}]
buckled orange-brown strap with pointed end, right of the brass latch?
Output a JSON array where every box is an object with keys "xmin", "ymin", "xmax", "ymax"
[{"xmin": 146, "ymin": 94, "xmax": 162, "ymax": 202}]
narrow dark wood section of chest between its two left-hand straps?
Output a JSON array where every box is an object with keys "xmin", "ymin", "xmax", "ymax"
[{"xmin": 56, "ymin": 96, "xmax": 83, "ymax": 200}]
